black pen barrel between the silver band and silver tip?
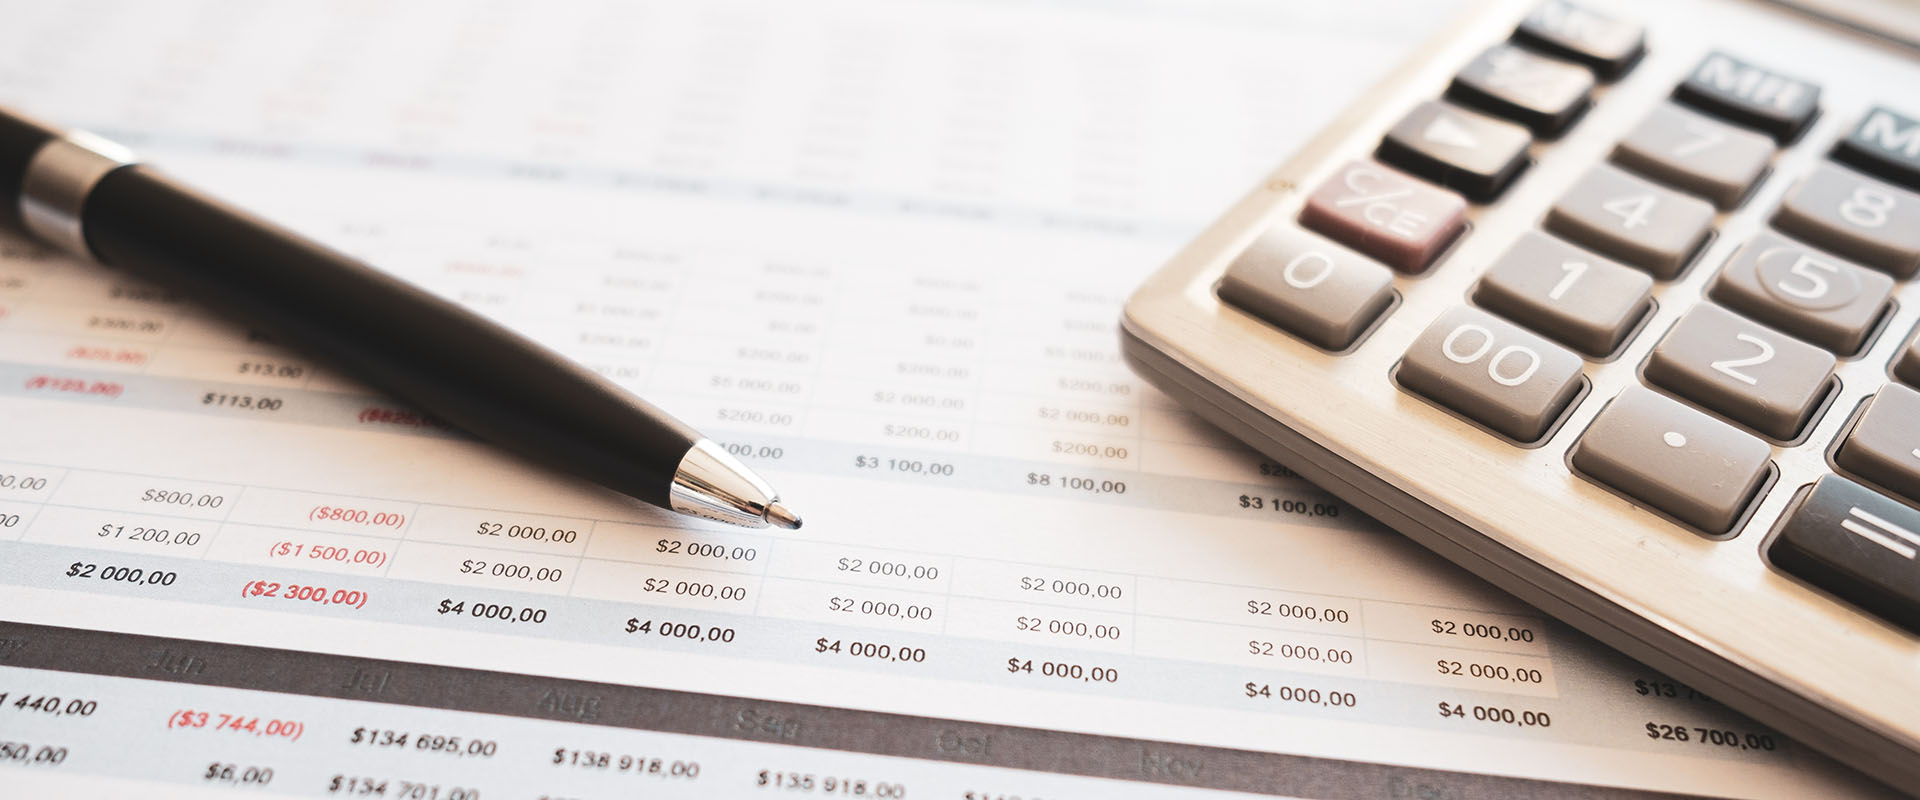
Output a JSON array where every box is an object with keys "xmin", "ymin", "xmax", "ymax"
[{"xmin": 81, "ymin": 165, "xmax": 699, "ymax": 506}]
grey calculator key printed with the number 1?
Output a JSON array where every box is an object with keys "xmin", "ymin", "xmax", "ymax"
[{"xmin": 1473, "ymin": 230, "xmax": 1653, "ymax": 357}]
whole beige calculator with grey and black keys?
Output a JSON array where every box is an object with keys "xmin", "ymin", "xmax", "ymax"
[{"xmin": 1121, "ymin": 0, "xmax": 1920, "ymax": 792}]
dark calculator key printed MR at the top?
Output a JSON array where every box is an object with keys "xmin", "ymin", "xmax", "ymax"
[{"xmin": 1674, "ymin": 52, "xmax": 1820, "ymax": 144}]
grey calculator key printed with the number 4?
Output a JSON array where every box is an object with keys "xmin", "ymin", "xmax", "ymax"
[{"xmin": 1548, "ymin": 163, "xmax": 1713, "ymax": 280}]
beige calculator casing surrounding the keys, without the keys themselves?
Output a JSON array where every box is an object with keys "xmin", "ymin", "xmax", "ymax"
[{"xmin": 1121, "ymin": 0, "xmax": 1920, "ymax": 792}]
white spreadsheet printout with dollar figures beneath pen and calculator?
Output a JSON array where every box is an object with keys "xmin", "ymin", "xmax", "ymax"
[{"xmin": 0, "ymin": 0, "xmax": 1880, "ymax": 800}]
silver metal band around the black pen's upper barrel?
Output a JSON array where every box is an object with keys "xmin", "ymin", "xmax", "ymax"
[{"xmin": 19, "ymin": 130, "xmax": 134, "ymax": 259}]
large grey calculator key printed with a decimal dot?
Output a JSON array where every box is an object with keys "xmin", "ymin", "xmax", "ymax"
[{"xmin": 1569, "ymin": 386, "xmax": 1772, "ymax": 533}]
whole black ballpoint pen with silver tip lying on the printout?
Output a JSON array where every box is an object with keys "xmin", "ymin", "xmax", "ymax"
[{"xmin": 0, "ymin": 109, "xmax": 801, "ymax": 529}]
